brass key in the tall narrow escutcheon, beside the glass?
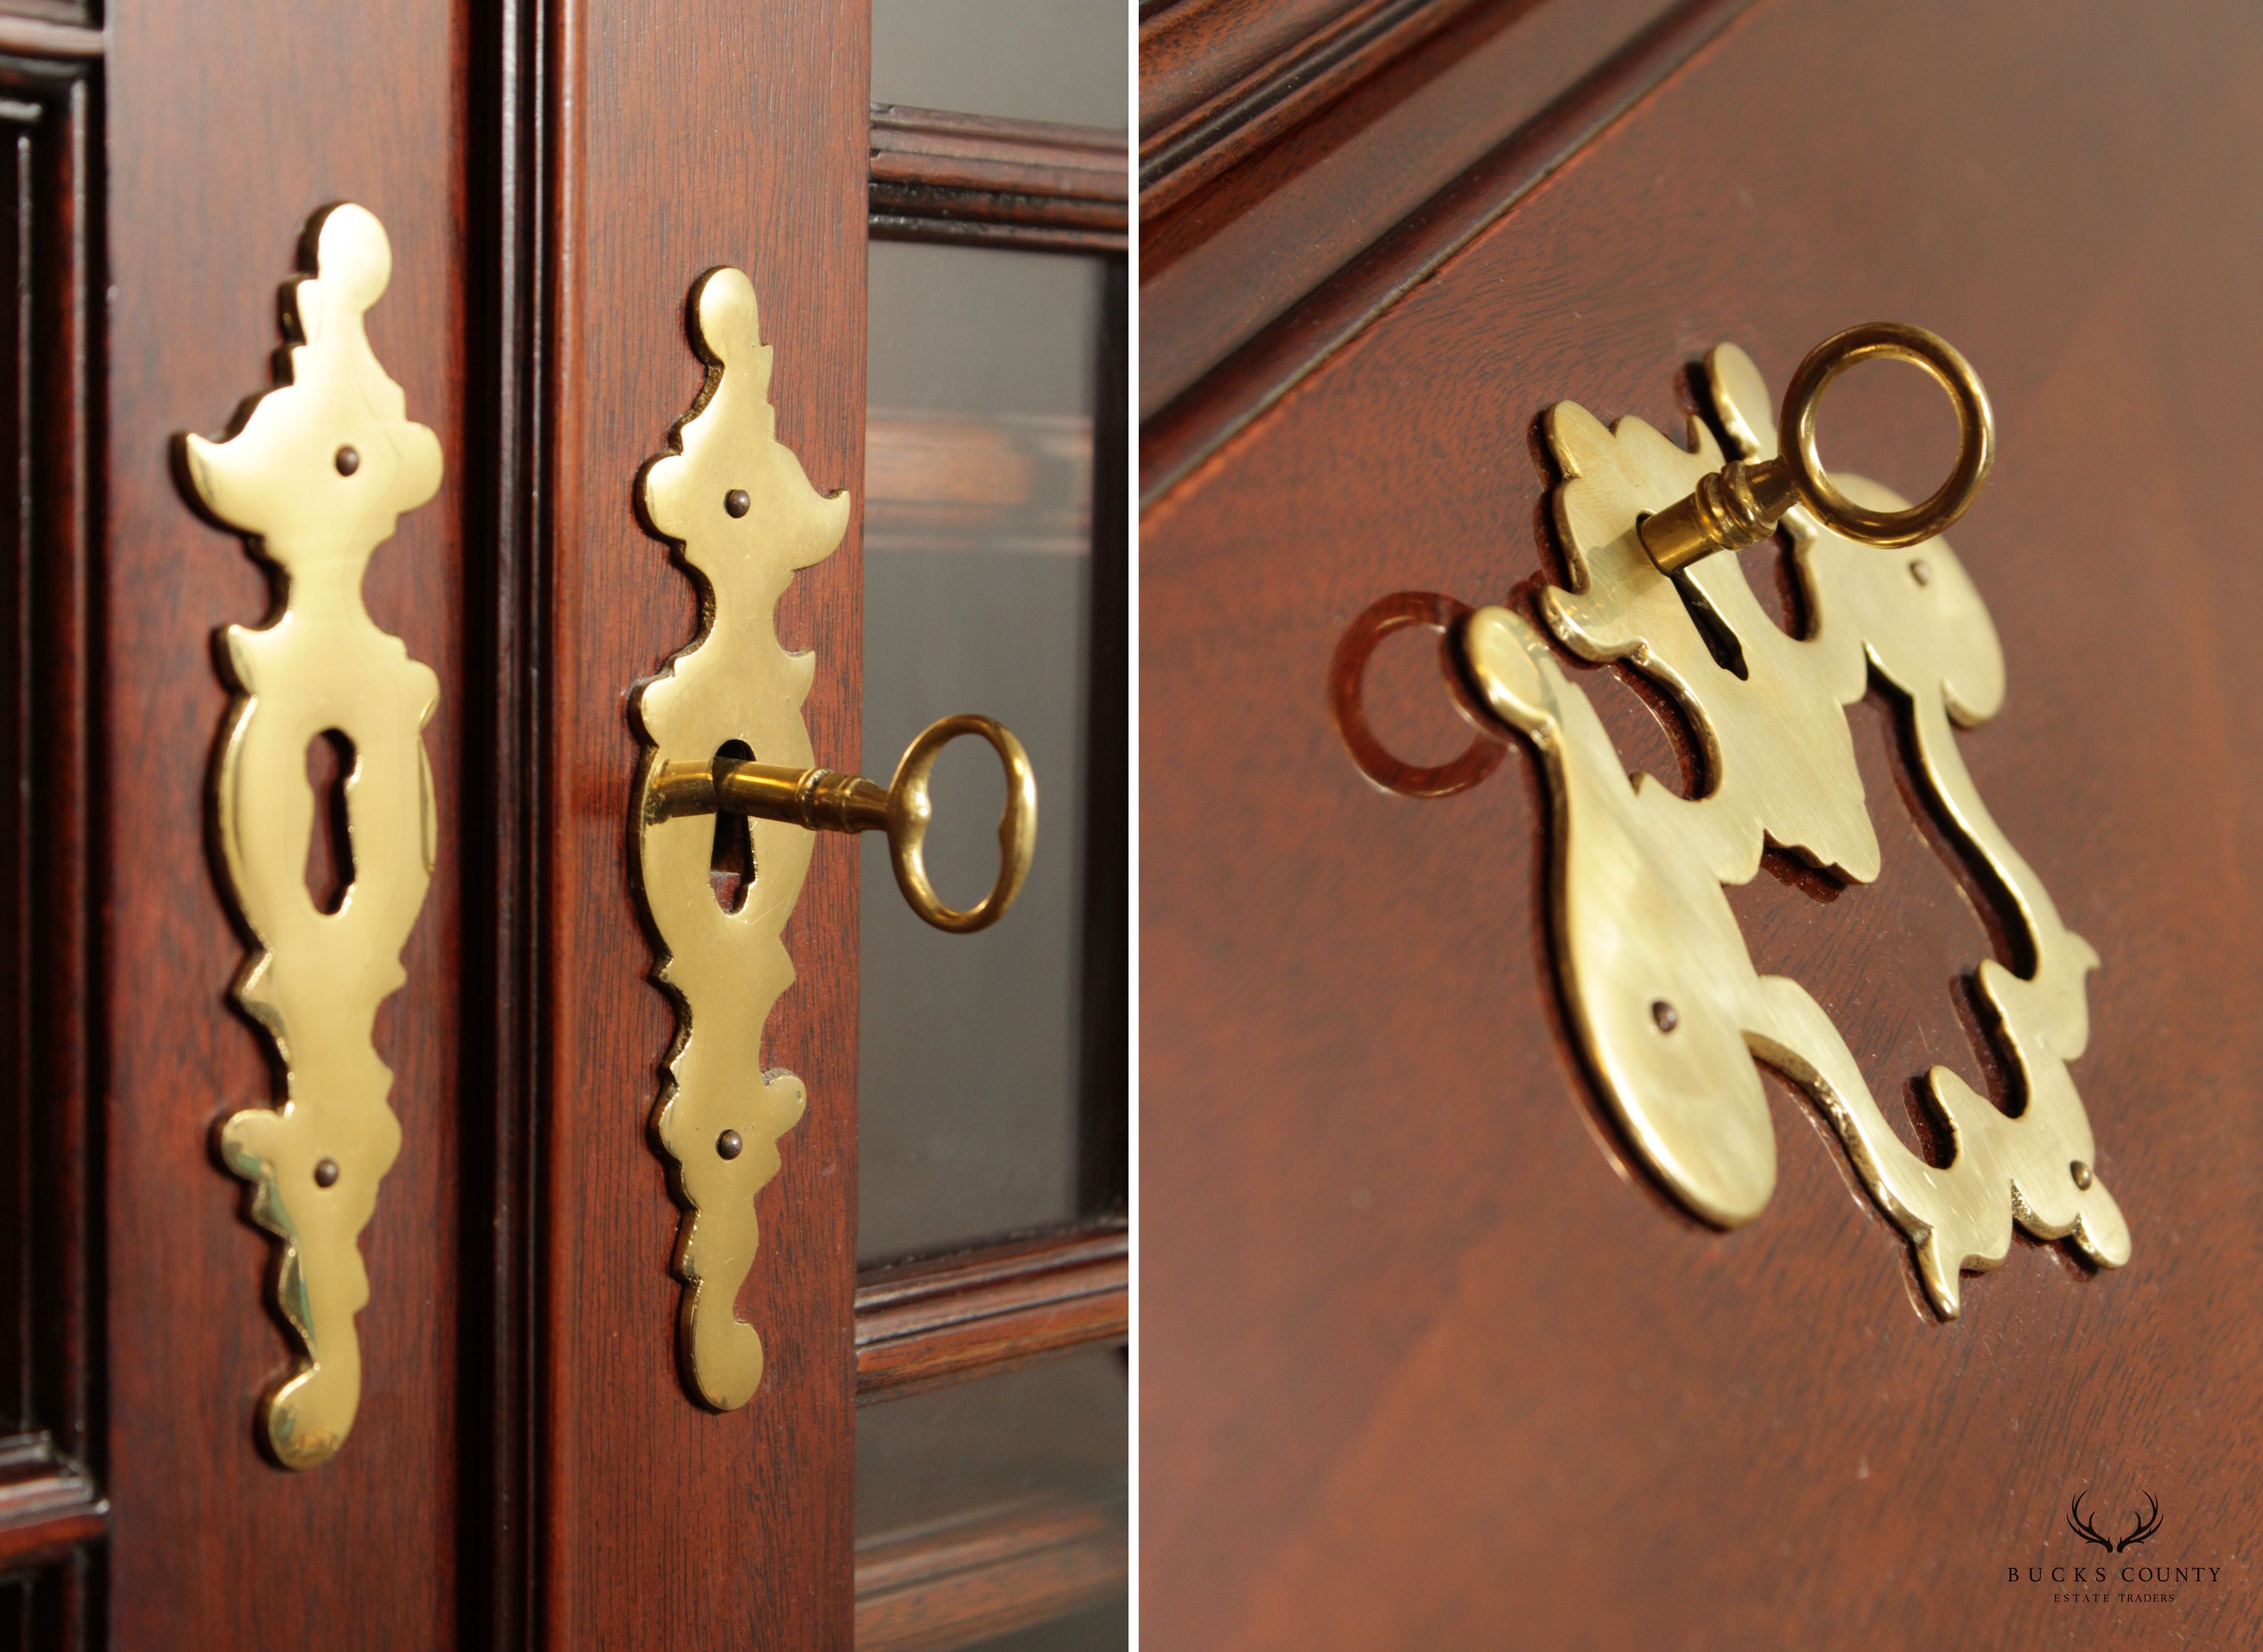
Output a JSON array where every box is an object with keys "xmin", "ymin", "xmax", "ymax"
[{"xmin": 645, "ymin": 715, "xmax": 1036, "ymax": 935}]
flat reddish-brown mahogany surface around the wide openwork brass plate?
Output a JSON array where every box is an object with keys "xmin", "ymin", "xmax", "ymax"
[{"xmin": 1140, "ymin": 0, "xmax": 2263, "ymax": 1652}]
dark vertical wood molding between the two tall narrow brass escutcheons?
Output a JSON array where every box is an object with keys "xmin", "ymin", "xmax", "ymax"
[{"xmin": 457, "ymin": 0, "xmax": 545, "ymax": 1652}]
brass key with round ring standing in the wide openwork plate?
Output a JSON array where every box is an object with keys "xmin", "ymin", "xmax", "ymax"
[{"xmin": 1638, "ymin": 321, "xmax": 1996, "ymax": 572}]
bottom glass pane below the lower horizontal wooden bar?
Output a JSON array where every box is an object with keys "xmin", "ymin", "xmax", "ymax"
[{"xmin": 855, "ymin": 1351, "xmax": 1129, "ymax": 1652}]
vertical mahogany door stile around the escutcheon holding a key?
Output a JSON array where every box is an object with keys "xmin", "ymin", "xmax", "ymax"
[{"xmin": 534, "ymin": 0, "xmax": 869, "ymax": 1652}]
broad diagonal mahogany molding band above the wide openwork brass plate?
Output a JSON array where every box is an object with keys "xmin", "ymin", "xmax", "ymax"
[{"xmin": 1138, "ymin": 0, "xmax": 1747, "ymax": 457}]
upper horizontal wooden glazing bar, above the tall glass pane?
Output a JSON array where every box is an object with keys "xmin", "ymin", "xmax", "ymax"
[{"xmin": 869, "ymin": 104, "xmax": 1132, "ymax": 254}]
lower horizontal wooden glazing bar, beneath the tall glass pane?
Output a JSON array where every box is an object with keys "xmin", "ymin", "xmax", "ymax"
[{"xmin": 855, "ymin": 1226, "xmax": 1132, "ymax": 1405}]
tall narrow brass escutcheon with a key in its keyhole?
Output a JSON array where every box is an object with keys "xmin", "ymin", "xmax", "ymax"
[{"xmin": 631, "ymin": 269, "xmax": 849, "ymax": 1412}]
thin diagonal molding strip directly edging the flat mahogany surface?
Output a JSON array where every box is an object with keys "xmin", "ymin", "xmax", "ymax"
[{"xmin": 1140, "ymin": 0, "xmax": 1751, "ymax": 509}]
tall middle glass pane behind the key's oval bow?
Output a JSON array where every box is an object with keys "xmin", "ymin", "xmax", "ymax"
[{"xmin": 858, "ymin": 242, "xmax": 1100, "ymax": 1258}]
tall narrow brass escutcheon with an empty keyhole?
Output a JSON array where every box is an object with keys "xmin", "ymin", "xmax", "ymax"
[{"xmin": 179, "ymin": 206, "xmax": 441, "ymax": 1468}]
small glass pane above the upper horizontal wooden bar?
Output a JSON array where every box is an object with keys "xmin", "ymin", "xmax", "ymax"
[{"xmin": 871, "ymin": 0, "xmax": 1132, "ymax": 129}]
